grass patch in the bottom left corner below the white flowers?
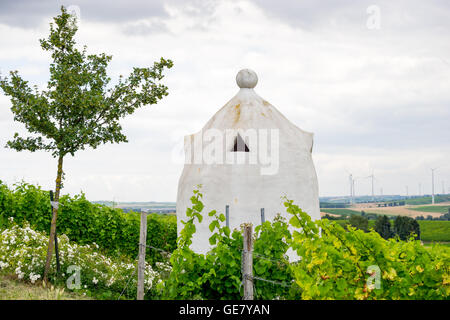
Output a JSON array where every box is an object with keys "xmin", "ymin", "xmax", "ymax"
[{"xmin": 0, "ymin": 276, "xmax": 89, "ymax": 300}]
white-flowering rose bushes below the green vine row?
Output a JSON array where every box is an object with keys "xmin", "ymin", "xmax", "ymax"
[{"xmin": 0, "ymin": 219, "xmax": 170, "ymax": 300}]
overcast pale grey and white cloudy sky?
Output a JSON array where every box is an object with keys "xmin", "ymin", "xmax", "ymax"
[{"xmin": 0, "ymin": 0, "xmax": 450, "ymax": 201}]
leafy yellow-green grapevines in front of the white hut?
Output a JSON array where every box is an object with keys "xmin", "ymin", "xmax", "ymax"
[{"xmin": 163, "ymin": 190, "xmax": 450, "ymax": 299}]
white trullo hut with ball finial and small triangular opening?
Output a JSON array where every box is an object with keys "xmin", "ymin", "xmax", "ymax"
[{"xmin": 176, "ymin": 69, "xmax": 320, "ymax": 253}]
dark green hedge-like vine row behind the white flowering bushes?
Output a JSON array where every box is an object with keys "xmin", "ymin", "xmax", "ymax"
[{"xmin": 0, "ymin": 180, "xmax": 177, "ymax": 260}]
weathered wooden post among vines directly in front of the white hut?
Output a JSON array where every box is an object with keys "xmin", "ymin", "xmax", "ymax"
[{"xmin": 242, "ymin": 223, "xmax": 253, "ymax": 300}]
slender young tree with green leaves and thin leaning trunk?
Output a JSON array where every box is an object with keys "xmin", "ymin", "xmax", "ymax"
[{"xmin": 0, "ymin": 7, "xmax": 172, "ymax": 282}]
